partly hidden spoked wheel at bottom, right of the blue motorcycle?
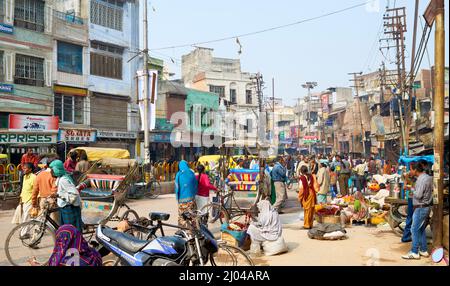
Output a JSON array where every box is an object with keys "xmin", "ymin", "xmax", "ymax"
[{"xmin": 210, "ymin": 243, "xmax": 255, "ymax": 266}]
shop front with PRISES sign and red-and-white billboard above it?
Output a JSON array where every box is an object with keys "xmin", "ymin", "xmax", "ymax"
[{"xmin": 0, "ymin": 114, "xmax": 59, "ymax": 165}]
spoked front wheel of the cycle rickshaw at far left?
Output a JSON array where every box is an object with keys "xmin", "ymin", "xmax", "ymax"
[{"xmin": 5, "ymin": 221, "xmax": 56, "ymax": 266}]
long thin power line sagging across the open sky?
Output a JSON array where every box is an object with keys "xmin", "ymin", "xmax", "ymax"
[{"xmin": 150, "ymin": 0, "xmax": 375, "ymax": 51}]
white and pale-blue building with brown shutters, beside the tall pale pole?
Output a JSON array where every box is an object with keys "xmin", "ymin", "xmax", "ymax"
[{"xmin": 81, "ymin": 0, "xmax": 142, "ymax": 155}]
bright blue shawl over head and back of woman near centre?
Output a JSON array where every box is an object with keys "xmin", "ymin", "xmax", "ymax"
[{"xmin": 175, "ymin": 160, "xmax": 198, "ymax": 203}]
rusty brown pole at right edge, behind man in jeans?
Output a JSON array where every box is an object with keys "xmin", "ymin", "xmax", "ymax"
[{"xmin": 427, "ymin": 0, "xmax": 445, "ymax": 250}]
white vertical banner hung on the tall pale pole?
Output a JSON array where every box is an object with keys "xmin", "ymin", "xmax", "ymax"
[{"xmin": 137, "ymin": 70, "xmax": 158, "ymax": 131}]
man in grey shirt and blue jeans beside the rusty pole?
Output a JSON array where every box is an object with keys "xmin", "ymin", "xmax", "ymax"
[{"xmin": 402, "ymin": 163, "xmax": 433, "ymax": 259}]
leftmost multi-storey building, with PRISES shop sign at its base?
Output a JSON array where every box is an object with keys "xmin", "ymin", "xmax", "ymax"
[{"xmin": 0, "ymin": 0, "xmax": 58, "ymax": 162}]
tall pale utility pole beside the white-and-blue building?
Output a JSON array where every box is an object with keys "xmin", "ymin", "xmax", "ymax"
[{"xmin": 142, "ymin": 0, "xmax": 150, "ymax": 166}]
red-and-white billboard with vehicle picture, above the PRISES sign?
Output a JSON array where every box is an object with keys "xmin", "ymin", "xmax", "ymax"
[{"xmin": 9, "ymin": 114, "xmax": 59, "ymax": 132}]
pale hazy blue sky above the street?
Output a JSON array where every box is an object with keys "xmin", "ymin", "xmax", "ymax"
[{"xmin": 149, "ymin": 0, "xmax": 449, "ymax": 105}]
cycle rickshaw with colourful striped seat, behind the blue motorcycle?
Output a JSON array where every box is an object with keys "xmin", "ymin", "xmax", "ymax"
[{"xmin": 5, "ymin": 158, "xmax": 139, "ymax": 266}]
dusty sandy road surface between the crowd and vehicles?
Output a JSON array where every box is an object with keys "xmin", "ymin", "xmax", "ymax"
[{"xmin": 0, "ymin": 191, "xmax": 445, "ymax": 266}]
